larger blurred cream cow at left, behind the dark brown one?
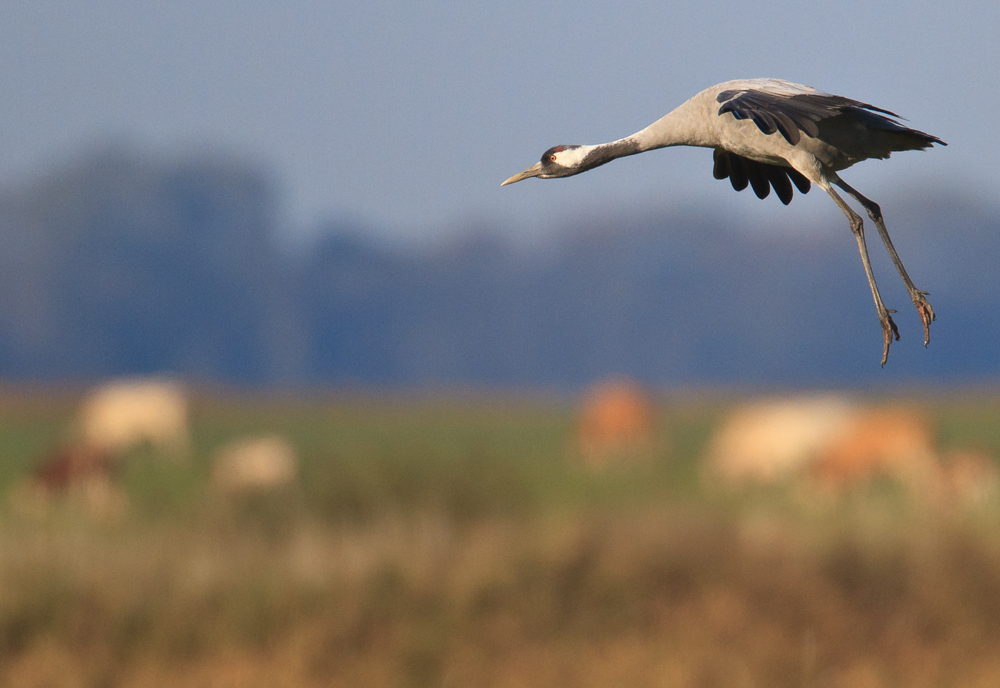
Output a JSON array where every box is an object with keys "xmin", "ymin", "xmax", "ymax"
[{"xmin": 78, "ymin": 378, "xmax": 189, "ymax": 456}]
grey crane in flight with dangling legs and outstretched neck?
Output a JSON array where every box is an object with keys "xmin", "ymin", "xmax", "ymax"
[{"xmin": 501, "ymin": 79, "xmax": 947, "ymax": 366}]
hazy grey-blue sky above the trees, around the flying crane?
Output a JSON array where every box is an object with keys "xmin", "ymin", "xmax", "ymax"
[{"xmin": 0, "ymin": 0, "xmax": 1000, "ymax": 238}]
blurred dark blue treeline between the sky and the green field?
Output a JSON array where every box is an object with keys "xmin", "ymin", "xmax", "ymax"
[{"xmin": 0, "ymin": 148, "xmax": 1000, "ymax": 388}]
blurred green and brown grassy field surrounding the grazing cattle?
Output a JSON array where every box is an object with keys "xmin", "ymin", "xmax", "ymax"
[{"xmin": 0, "ymin": 390, "xmax": 1000, "ymax": 688}]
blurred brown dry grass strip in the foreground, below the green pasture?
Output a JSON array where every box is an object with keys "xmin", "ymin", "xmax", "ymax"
[{"xmin": 0, "ymin": 505, "xmax": 1000, "ymax": 688}]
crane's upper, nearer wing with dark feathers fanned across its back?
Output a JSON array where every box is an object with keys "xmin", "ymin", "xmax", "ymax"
[{"xmin": 716, "ymin": 81, "xmax": 905, "ymax": 146}]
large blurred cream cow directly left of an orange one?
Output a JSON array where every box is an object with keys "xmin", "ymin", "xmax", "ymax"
[{"xmin": 706, "ymin": 395, "xmax": 856, "ymax": 483}]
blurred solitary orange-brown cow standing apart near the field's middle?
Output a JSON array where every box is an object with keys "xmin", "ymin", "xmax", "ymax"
[{"xmin": 577, "ymin": 377, "xmax": 653, "ymax": 468}]
